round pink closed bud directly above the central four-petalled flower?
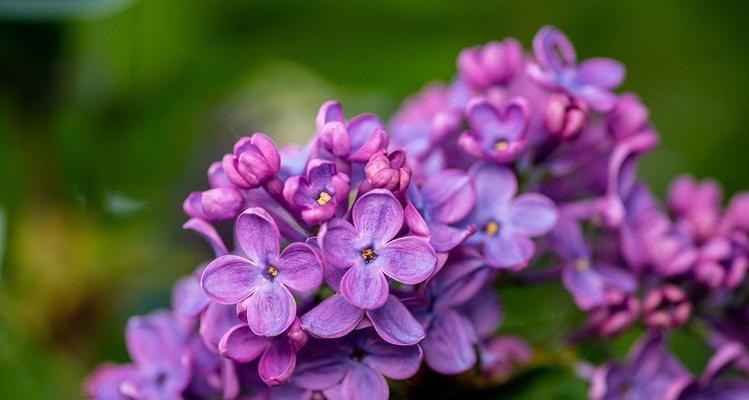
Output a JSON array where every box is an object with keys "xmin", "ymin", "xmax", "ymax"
[{"xmin": 364, "ymin": 150, "xmax": 411, "ymax": 193}]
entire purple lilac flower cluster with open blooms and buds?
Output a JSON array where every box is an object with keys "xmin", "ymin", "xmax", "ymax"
[{"xmin": 86, "ymin": 27, "xmax": 749, "ymax": 399}]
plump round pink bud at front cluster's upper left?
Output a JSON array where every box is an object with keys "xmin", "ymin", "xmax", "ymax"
[{"xmin": 222, "ymin": 133, "xmax": 281, "ymax": 189}]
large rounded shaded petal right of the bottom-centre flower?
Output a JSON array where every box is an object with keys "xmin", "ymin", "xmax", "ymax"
[{"xmin": 421, "ymin": 308, "xmax": 477, "ymax": 375}]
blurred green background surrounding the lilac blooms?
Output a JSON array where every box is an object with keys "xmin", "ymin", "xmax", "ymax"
[{"xmin": 0, "ymin": 0, "xmax": 749, "ymax": 399}]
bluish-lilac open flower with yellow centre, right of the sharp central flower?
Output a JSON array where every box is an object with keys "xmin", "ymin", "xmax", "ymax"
[{"xmin": 468, "ymin": 164, "xmax": 558, "ymax": 268}]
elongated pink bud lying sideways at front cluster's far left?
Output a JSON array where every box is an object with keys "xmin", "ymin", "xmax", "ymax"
[{"xmin": 182, "ymin": 187, "xmax": 244, "ymax": 221}]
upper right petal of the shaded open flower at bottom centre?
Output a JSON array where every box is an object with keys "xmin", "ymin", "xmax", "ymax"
[{"xmin": 362, "ymin": 340, "xmax": 422, "ymax": 380}]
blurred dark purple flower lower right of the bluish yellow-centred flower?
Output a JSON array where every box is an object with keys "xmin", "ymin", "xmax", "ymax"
[{"xmin": 550, "ymin": 216, "xmax": 637, "ymax": 310}]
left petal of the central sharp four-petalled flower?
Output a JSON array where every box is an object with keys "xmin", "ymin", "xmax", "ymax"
[{"xmin": 317, "ymin": 218, "xmax": 361, "ymax": 268}]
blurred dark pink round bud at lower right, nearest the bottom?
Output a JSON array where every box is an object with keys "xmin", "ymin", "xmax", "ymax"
[{"xmin": 642, "ymin": 284, "xmax": 692, "ymax": 329}]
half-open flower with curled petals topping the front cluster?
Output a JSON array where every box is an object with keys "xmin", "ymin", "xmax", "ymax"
[{"xmin": 317, "ymin": 101, "xmax": 389, "ymax": 163}]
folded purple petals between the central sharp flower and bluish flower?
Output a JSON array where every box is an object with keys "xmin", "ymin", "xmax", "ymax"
[{"xmin": 406, "ymin": 169, "xmax": 476, "ymax": 253}]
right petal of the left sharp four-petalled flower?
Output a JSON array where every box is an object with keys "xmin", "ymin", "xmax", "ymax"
[{"xmin": 276, "ymin": 242, "xmax": 322, "ymax": 292}]
